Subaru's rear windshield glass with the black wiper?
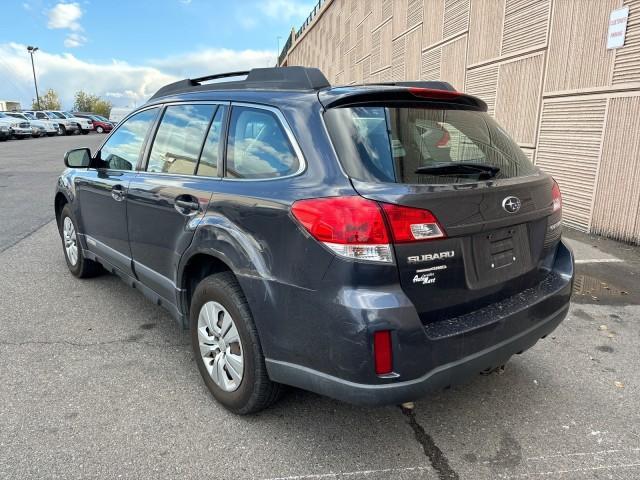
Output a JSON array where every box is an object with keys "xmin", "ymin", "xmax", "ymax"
[{"xmin": 325, "ymin": 106, "xmax": 535, "ymax": 184}]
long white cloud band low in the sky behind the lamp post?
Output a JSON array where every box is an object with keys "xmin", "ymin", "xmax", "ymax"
[{"xmin": 0, "ymin": 43, "xmax": 275, "ymax": 108}]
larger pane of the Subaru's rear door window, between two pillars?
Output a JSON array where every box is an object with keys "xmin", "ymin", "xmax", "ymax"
[{"xmin": 147, "ymin": 105, "xmax": 217, "ymax": 175}]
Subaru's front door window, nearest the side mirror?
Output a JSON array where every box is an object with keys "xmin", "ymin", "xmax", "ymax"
[{"xmin": 100, "ymin": 108, "xmax": 158, "ymax": 170}]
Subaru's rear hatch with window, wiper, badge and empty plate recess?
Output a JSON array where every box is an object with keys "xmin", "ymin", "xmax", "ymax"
[{"xmin": 321, "ymin": 88, "xmax": 561, "ymax": 323}]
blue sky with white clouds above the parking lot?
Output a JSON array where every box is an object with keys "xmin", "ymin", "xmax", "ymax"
[{"xmin": 0, "ymin": 0, "xmax": 313, "ymax": 108}]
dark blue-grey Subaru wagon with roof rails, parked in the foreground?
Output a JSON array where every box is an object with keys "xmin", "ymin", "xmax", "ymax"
[{"xmin": 55, "ymin": 67, "xmax": 574, "ymax": 414}]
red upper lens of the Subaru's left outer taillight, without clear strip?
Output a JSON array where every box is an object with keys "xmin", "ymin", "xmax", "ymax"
[{"xmin": 291, "ymin": 196, "xmax": 389, "ymax": 245}]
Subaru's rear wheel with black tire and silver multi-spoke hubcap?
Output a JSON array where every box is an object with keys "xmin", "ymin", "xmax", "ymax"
[{"xmin": 190, "ymin": 272, "xmax": 282, "ymax": 415}]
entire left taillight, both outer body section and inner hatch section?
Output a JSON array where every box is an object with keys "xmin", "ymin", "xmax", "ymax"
[{"xmin": 291, "ymin": 196, "xmax": 445, "ymax": 263}]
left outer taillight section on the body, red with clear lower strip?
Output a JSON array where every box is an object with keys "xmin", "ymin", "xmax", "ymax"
[{"xmin": 291, "ymin": 196, "xmax": 393, "ymax": 263}]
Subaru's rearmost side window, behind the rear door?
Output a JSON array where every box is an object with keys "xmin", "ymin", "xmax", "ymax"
[{"xmin": 227, "ymin": 107, "xmax": 300, "ymax": 178}]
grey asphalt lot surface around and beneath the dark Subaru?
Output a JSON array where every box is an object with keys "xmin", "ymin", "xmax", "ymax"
[{"xmin": 0, "ymin": 134, "xmax": 640, "ymax": 480}]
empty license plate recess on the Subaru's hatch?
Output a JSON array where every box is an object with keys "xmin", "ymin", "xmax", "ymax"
[{"xmin": 469, "ymin": 225, "xmax": 532, "ymax": 288}]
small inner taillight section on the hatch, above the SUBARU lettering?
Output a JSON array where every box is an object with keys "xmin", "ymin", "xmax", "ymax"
[{"xmin": 382, "ymin": 203, "xmax": 445, "ymax": 243}]
